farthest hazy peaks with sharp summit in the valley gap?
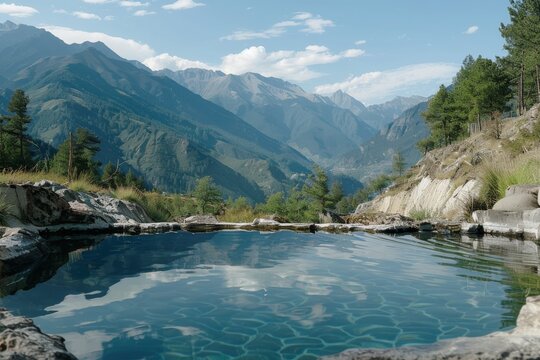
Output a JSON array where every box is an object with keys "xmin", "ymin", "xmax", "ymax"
[{"xmin": 329, "ymin": 90, "xmax": 426, "ymax": 130}]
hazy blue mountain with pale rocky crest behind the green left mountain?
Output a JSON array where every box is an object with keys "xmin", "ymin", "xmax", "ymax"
[{"xmin": 159, "ymin": 69, "xmax": 375, "ymax": 166}]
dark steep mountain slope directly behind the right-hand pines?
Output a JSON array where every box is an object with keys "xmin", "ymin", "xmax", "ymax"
[{"xmin": 333, "ymin": 101, "xmax": 429, "ymax": 180}]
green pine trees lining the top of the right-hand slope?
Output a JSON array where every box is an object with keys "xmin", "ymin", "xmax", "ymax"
[{"xmin": 418, "ymin": 0, "xmax": 540, "ymax": 153}]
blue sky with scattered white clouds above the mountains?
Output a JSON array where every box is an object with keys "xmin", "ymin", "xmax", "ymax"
[{"xmin": 0, "ymin": 0, "xmax": 509, "ymax": 105}]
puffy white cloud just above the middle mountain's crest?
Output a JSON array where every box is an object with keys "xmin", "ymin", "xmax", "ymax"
[{"xmin": 219, "ymin": 45, "xmax": 363, "ymax": 81}]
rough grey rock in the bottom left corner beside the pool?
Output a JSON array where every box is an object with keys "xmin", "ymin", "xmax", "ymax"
[{"xmin": 0, "ymin": 308, "xmax": 76, "ymax": 360}]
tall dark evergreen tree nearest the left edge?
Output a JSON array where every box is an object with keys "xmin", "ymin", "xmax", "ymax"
[{"xmin": 6, "ymin": 89, "xmax": 31, "ymax": 168}]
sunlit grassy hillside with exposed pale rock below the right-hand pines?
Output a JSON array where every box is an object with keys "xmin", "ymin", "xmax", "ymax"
[{"xmin": 357, "ymin": 105, "xmax": 540, "ymax": 219}]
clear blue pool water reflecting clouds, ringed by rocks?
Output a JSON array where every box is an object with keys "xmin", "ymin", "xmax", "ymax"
[{"xmin": 0, "ymin": 232, "xmax": 539, "ymax": 359}]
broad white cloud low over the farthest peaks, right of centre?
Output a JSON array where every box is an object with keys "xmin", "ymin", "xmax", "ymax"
[{"xmin": 315, "ymin": 63, "xmax": 459, "ymax": 105}]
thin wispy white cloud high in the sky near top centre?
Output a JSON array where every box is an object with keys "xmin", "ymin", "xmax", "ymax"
[{"xmin": 221, "ymin": 12, "xmax": 334, "ymax": 40}]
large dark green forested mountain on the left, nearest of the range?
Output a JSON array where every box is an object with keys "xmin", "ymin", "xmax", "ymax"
[{"xmin": 0, "ymin": 23, "xmax": 311, "ymax": 200}]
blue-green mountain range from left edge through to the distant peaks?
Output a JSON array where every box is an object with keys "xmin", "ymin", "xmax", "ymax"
[{"xmin": 0, "ymin": 22, "xmax": 430, "ymax": 201}]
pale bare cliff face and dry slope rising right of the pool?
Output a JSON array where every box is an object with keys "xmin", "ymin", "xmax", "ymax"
[{"xmin": 357, "ymin": 106, "xmax": 539, "ymax": 220}]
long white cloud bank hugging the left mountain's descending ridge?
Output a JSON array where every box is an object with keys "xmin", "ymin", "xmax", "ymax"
[{"xmin": 43, "ymin": 26, "xmax": 155, "ymax": 61}]
